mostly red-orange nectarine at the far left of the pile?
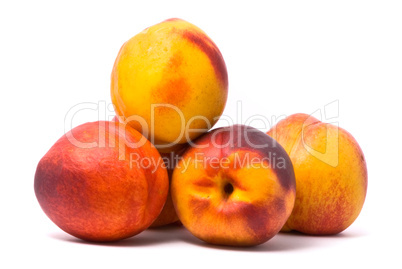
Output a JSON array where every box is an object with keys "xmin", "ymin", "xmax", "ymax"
[{"xmin": 34, "ymin": 122, "xmax": 169, "ymax": 241}]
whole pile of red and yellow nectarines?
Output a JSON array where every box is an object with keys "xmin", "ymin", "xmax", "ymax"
[{"xmin": 34, "ymin": 19, "xmax": 367, "ymax": 246}]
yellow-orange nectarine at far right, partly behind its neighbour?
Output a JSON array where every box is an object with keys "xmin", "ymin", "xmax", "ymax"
[{"xmin": 268, "ymin": 114, "xmax": 367, "ymax": 235}]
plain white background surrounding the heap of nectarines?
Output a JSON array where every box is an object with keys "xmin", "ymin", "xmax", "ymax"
[{"xmin": 0, "ymin": 0, "xmax": 402, "ymax": 268}]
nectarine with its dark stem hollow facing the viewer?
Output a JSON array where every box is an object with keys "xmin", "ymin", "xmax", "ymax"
[{"xmin": 171, "ymin": 125, "xmax": 295, "ymax": 246}]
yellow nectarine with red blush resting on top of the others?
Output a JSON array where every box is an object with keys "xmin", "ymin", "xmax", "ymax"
[{"xmin": 111, "ymin": 19, "xmax": 228, "ymax": 149}]
